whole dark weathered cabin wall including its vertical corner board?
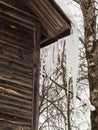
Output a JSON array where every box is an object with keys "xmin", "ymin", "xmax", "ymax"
[{"xmin": 0, "ymin": 1, "xmax": 40, "ymax": 130}]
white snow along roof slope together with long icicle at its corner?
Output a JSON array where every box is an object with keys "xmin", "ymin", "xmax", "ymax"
[{"xmin": 55, "ymin": 0, "xmax": 79, "ymax": 108}]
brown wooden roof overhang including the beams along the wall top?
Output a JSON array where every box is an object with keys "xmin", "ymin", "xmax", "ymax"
[{"xmin": 0, "ymin": 0, "xmax": 71, "ymax": 47}]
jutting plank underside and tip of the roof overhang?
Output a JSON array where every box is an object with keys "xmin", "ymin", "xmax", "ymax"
[{"xmin": 21, "ymin": 0, "xmax": 71, "ymax": 47}]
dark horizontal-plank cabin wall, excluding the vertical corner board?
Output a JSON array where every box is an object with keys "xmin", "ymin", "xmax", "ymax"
[{"xmin": 0, "ymin": 22, "xmax": 33, "ymax": 130}]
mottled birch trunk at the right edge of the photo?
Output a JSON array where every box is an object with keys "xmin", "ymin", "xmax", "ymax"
[{"xmin": 80, "ymin": 0, "xmax": 98, "ymax": 130}]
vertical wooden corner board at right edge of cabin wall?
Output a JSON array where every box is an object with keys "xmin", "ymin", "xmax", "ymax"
[{"xmin": 32, "ymin": 23, "xmax": 41, "ymax": 130}]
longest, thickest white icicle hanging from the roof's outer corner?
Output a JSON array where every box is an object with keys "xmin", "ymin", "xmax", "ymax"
[{"xmin": 65, "ymin": 25, "xmax": 79, "ymax": 109}]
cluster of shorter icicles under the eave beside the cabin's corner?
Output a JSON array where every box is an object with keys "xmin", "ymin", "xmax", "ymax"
[{"xmin": 40, "ymin": 42, "xmax": 59, "ymax": 77}]
